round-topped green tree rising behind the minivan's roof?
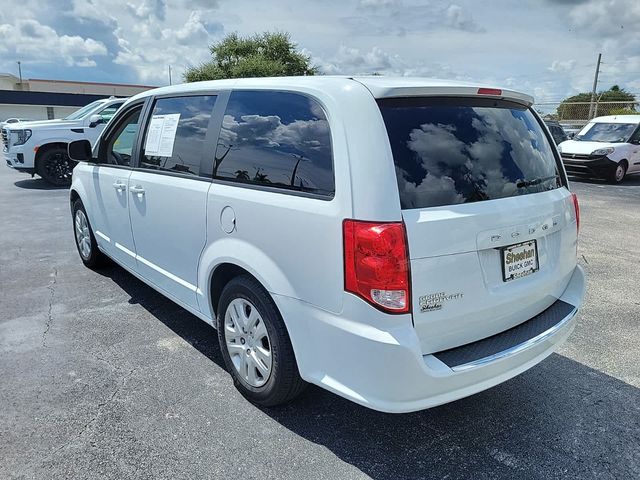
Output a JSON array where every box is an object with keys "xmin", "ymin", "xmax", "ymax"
[{"xmin": 184, "ymin": 32, "xmax": 318, "ymax": 82}]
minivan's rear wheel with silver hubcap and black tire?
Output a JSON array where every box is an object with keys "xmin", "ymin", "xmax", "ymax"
[{"xmin": 216, "ymin": 275, "xmax": 307, "ymax": 407}]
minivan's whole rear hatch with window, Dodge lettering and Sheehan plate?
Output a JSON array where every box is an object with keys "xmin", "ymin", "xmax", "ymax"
[{"xmin": 378, "ymin": 96, "xmax": 577, "ymax": 354}]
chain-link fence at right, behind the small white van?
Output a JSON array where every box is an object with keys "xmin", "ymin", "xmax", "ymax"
[{"xmin": 534, "ymin": 101, "xmax": 640, "ymax": 128}]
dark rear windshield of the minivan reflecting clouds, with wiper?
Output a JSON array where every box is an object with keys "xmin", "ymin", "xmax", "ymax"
[{"xmin": 378, "ymin": 98, "xmax": 561, "ymax": 209}]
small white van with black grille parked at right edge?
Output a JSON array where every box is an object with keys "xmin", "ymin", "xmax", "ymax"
[{"xmin": 558, "ymin": 115, "xmax": 640, "ymax": 183}]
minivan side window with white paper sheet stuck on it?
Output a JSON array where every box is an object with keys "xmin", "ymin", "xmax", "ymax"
[{"xmin": 140, "ymin": 95, "xmax": 216, "ymax": 175}]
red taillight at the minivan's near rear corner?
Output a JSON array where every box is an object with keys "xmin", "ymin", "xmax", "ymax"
[{"xmin": 343, "ymin": 220, "xmax": 411, "ymax": 313}]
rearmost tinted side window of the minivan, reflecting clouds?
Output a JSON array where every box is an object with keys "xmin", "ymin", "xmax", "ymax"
[{"xmin": 214, "ymin": 91, "xmax": 335, "ymax": 197}]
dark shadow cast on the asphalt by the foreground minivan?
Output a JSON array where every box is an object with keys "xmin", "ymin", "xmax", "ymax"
[{"xmin": 97, "ymin": 267, "xmax": 640, "ymax": 480}]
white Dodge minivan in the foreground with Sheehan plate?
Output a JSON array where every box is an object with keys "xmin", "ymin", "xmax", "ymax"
[{"xmin": 69, "ymin": 77, "xmax": 585, "ymax": 412}]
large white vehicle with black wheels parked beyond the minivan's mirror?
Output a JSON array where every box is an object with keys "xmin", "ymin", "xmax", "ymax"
[{"xmin": 1, "ymin": 97, "xmax": 126, "ymax": 186}]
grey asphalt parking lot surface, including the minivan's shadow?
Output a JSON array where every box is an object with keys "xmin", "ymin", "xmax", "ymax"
[{"xmin": 0, "ymin": 167, "xmax": 640, "ymax": 480}]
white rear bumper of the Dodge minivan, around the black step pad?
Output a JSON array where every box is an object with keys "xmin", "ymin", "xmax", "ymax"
[{"xmin": 274, "ymin": 266, "xmax": 585, "ymax": 413}]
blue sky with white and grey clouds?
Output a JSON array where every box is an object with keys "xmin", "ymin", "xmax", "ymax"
[{"xmin": 0, "ymin": 0, "xmax": 640, "ymax": 102}]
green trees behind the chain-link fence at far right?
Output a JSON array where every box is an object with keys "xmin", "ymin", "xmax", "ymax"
[{"xmin": 557, "ymin": 85, "xmax": 638, "ymax": 120}]
